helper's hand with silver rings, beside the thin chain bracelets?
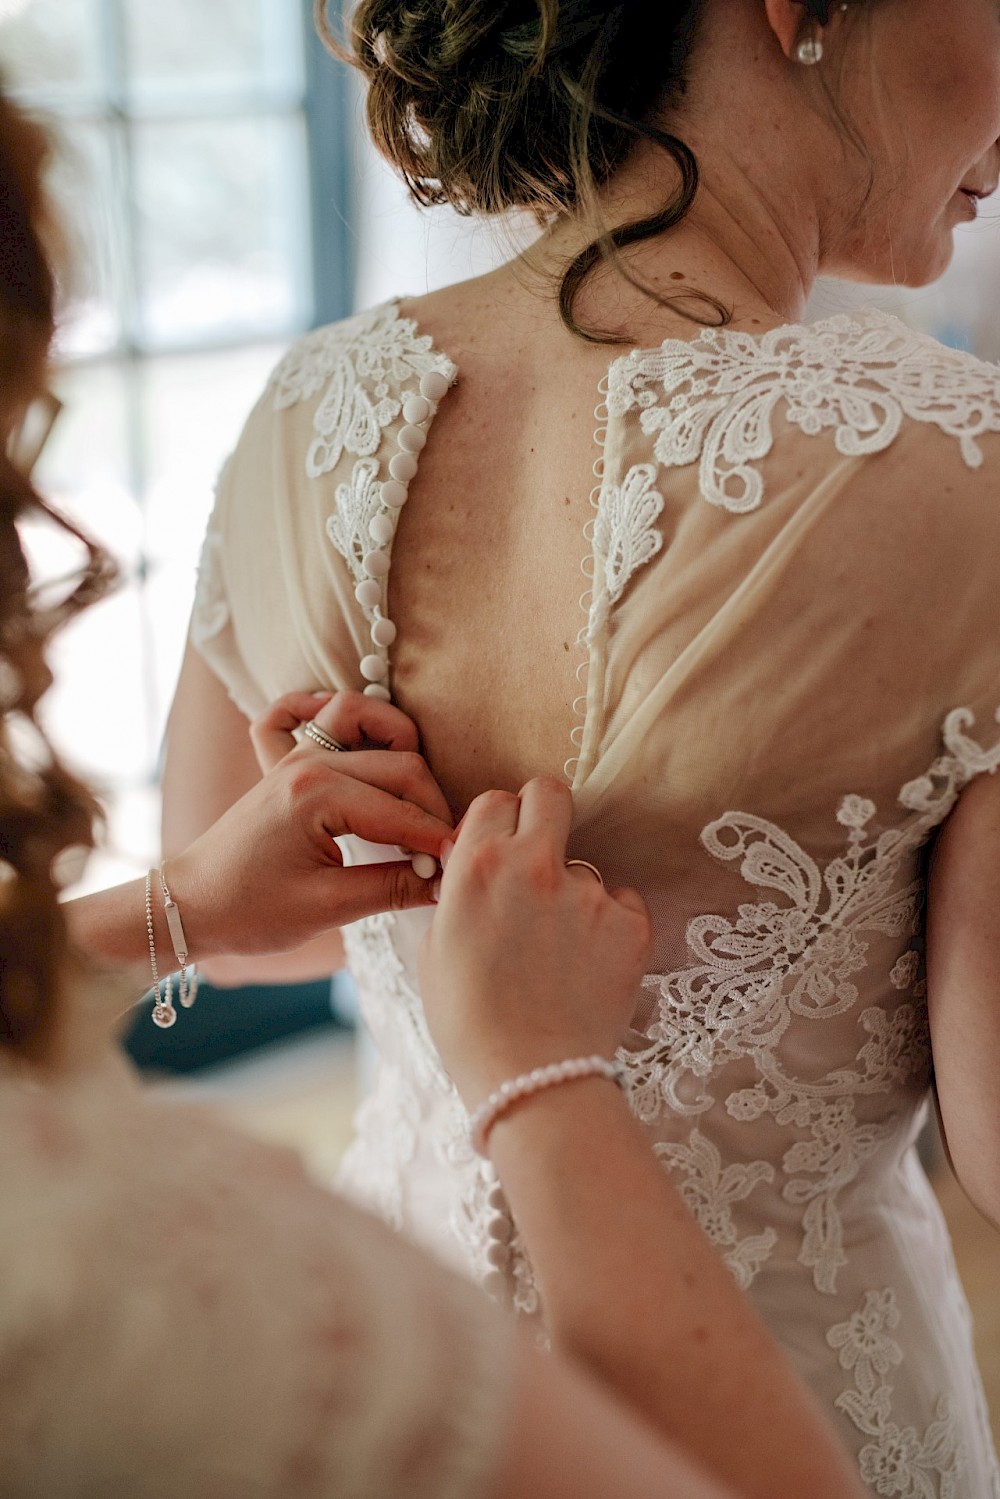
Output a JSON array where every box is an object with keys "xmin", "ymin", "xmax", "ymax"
[{"xmin": 166, "ymin": 693, "xmax": 453, "ymax": 961}]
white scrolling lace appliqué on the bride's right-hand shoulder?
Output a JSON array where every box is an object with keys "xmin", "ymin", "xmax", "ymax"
[{"xmin": 609, "ymin": 313, "xmax": 1000, "ymax": 514}]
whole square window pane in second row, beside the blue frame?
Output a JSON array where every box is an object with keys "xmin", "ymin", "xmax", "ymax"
[{"xmin": 135, "ymin": 117, "xmax": 309, "ymax": 348}]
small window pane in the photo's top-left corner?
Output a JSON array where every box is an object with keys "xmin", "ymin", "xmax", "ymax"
[{"xmin": 0, "ymin": 0, "xmax": 100, "ymax": 94}]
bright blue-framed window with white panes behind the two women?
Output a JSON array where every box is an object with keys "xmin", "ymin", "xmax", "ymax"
[{"xmin": 0, "ymin": 0, "xmax": 351, "ymax": 886}]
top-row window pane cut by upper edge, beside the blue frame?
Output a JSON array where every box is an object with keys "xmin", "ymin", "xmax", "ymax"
[{"xmin": 124, "ymin": 0, "xmax": 301, "ymax": 101}]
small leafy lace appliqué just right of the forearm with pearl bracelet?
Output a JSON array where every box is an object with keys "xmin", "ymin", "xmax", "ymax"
[{"xmin": 654, "ymin": 1129, "xmax": 778, "ymax": 1291}]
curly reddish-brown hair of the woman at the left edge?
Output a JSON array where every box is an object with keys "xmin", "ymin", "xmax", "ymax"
[{"xmin": 0, "ymin": 93, "xmax": 111, "ymax": 1061}]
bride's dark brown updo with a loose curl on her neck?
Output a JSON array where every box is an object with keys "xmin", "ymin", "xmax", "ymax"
[{"xmin": 316, "ymin": 0, "xmax": 710, "ymax": 342}]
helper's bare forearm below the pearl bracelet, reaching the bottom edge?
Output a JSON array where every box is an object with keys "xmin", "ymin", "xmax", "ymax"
[{"xmin": 490, "ymin": 1079, "xmax": 864, "ymax": 1499}]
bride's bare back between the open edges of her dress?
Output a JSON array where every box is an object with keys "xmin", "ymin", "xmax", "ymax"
[{"xmin": 388, "ymin": 277, "xmax": 615, "ymax": 809}]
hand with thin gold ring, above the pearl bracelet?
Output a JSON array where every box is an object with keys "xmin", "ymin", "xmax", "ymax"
[{"xmin": 420, "ymin": 779, "xmax": 651, "ymax": 1108}]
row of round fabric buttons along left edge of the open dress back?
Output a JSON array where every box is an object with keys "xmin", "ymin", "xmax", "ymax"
[{"xmin": 354, "ymin": 370, "xmax": 448, "ymax": 703}]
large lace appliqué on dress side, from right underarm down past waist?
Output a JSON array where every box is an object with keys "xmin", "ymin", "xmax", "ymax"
[{"xmin": 629, "ymin": 709, "xmax": 1000, "ymax": 1294}]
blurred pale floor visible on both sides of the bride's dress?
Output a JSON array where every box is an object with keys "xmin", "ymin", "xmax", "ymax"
[{"xmin": 157, "ymin": 1031, "xmax": 1000, "ymax": 1441}]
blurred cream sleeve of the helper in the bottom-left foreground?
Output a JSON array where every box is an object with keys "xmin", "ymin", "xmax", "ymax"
[{"xmin": 0, "ymin": 1078, "xmax": 514, "ymax": 1499}]
